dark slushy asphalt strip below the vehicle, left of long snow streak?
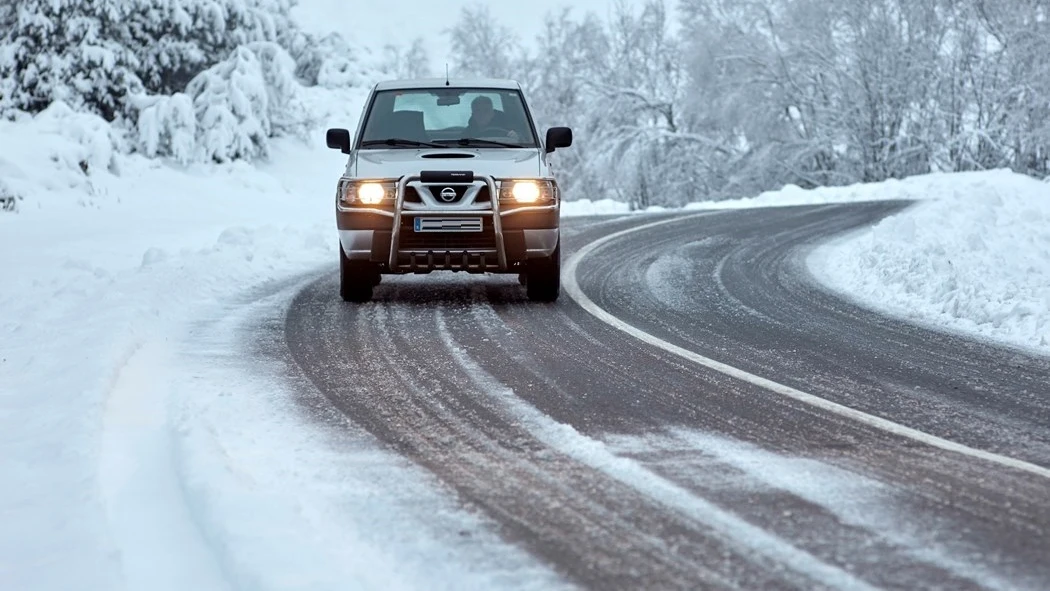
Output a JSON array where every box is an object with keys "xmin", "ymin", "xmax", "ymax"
[{"xmin": 285, "ymin": 277, "xmax": 852, "ymax": 589}]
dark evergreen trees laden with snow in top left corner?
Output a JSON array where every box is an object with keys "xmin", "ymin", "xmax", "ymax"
[{"xmin": 0, "ymin": 0, "xmax": 304, "ymax": 121}]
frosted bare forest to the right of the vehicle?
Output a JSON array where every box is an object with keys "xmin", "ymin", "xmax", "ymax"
[{"xmin": 450, "ymin": 0, "xmax": 1050, "ymax": 207}]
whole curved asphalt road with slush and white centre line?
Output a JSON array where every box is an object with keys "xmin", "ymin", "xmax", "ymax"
[{"xmin": 271, "ymin": 203, "xmax": 1050, "ymax": 589}]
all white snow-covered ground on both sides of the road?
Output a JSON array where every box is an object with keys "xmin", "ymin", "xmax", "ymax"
[{"xmin": 0, "ymin": 86, "xmax": 1050, "ymax": 589}]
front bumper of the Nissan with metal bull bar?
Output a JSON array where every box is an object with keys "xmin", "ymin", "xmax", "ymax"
[{"xmin": 336, "ymin": 176, "xmax": 560, "ymax": 273}]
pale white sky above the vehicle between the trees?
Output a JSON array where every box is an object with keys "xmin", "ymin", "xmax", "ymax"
[{"xmin": 295, "ymin": 0, "xmax": 642, "ymax": 75}]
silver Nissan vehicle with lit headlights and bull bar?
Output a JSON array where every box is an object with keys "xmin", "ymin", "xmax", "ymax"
[{"xmin": 327, "ymin": 79, "xmax": 572, "ymax": 302}]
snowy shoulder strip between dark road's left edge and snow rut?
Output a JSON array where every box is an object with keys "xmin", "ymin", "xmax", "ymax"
[{"xmin": 179, "ymin": 278, "xmax": 560, "ymax": 591}]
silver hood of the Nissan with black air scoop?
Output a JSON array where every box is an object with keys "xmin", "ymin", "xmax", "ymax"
[{"xmin": 348, "ymin": 148, "xmax": 543, "ymax": 178}]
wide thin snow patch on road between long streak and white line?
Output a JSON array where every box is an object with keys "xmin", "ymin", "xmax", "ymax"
[{"xmin": 605, "ymin": 428, "xmax": 1020, "ymax": 590}]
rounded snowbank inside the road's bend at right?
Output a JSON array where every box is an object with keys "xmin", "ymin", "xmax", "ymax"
[{"xmin": 810, "ymin": 171, "xmax": 1050, "ymax": 354}]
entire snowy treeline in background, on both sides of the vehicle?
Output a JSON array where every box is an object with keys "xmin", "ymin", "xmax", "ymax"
[{"xmin": 0, "ymin": 0, "xmax": 1050, "ymax": 208}]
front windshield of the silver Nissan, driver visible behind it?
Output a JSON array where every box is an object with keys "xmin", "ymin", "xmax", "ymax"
[{"xmin": 358, "ymin": 87, "xmax": 539, "ymax": 149}]
